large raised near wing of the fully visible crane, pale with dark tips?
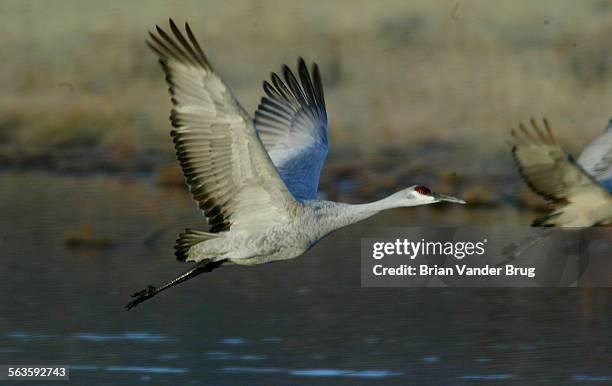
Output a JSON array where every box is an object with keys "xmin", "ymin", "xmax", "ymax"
[{"xmin": 147, "ymin": 20, "xmax": 295, "ymax": 237}]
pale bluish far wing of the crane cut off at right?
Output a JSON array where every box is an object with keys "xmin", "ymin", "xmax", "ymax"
[{"xmin": 576, "ymin": 119, "xmax": 612, "ymax": 193}]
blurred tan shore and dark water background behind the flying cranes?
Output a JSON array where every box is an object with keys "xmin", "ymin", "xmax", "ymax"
[{"xmin": 0, "ymin": 0, "xmax": 612, "ymax": 385}]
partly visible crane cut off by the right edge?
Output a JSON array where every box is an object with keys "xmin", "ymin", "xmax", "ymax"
[{"xmin": 512, "ymin": 118, "xmax": 612, "ymax": 227}]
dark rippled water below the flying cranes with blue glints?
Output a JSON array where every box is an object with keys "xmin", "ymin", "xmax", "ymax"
[{"xmin": 0, "ymin": 173, "xmax": 612, "ymax": 385}]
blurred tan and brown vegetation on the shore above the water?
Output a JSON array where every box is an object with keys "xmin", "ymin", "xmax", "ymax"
[{"xmin": 0, "ymin": 0, "xmax": 612, "ymax": 205}]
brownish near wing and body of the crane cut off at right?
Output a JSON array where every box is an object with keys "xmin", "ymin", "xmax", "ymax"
[{"xmin": 512, "ymin": 119, "xmax": 612, "ymax": 226}]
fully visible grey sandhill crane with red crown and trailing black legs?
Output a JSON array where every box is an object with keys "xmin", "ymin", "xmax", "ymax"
[{"xmin": 127, "ymin": 20, "xmax": 464, "ymax": 309}]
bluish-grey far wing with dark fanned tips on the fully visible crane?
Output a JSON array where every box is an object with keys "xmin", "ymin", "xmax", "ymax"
[{"xmin": 255, "ymin": 58, "xmax": 328, "ymax": 200}]
